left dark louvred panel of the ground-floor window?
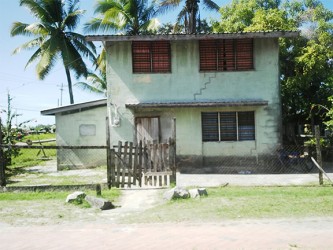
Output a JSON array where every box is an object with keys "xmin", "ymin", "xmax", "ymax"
[{"xmin": 201, "ymin": 112, "xmax": 219, "ymax": 141}]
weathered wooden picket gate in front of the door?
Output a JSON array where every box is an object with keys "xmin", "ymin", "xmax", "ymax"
[{"xmin": 107, "ymin": 139, "xmax": 175, "ymax": 187}]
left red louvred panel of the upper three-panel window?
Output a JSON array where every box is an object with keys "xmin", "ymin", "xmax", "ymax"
[{"xmin": 199, "ymin": 40, "xmax": 217, "ymax": 71}]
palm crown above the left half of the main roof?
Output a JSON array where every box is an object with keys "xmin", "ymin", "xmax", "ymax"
[{"xmin": 85, "ymin": 0, "xmax": 159, "ymax": 35}]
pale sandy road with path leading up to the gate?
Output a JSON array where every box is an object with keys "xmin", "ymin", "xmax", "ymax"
[{"xmin": 0, "ymin": 189, "xmax": 333, "ymax": 250}]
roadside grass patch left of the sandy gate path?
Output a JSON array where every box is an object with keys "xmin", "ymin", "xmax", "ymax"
[{"xmin": 0, "ymin": 189, "xmax": 120, "ymax": 226}]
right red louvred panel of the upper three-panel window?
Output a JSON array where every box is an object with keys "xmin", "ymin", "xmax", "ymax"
[{"xmin": 236, "ymin": 39, "xmax": 253, "ymax": 70}]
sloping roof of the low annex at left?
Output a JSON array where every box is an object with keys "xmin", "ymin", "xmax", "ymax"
[{"xmin": 40, "ymin": 99, "xmax": 107, "ymax": 115}]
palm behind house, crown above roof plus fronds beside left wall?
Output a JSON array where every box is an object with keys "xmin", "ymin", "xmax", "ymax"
[{"xmin": 82, "ymin": 0, "xmax": 159, "ymax": 94}]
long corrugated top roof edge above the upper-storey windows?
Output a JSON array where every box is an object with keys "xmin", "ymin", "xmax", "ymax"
[{"xmin": 86, "ymin": 30, "xmax": 300, "ymax": 42}]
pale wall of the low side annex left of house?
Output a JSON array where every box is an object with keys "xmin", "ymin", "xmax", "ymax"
[{"xmin": 56, "ymin": 107, "xmax": 106, "ymax": 170}]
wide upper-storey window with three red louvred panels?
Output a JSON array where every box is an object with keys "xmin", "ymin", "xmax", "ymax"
[{"xmin": 199, "ymin": 39, "xmax": 253, "ymax": 71}]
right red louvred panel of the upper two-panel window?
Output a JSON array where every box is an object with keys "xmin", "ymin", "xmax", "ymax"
[{"xmin": 152, "ymin": 41, "xmax": 171, "ymax": 73}]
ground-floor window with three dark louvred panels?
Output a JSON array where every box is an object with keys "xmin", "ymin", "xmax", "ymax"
[{"xmin": 201, "ymin": 111, "xmax": 255, "ymax": 142}]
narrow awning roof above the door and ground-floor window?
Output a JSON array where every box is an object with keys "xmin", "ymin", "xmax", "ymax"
[{"xmin": 126, "ymin": 99, "xmax": 268, "ymax": 109}]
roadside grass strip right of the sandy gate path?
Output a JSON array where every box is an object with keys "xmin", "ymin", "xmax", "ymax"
[{"xmin": 123, "ymin": 186, "xmax": 333, "ymax": 223}]
